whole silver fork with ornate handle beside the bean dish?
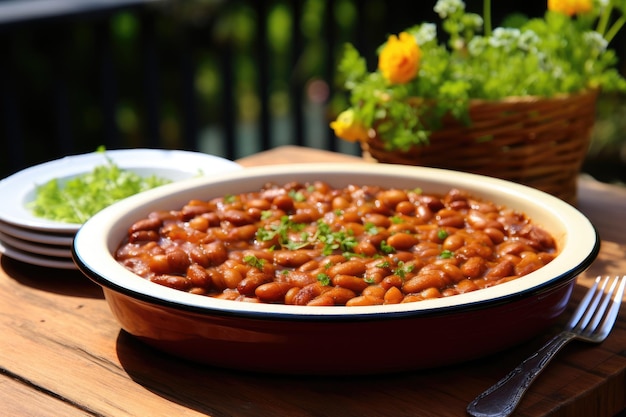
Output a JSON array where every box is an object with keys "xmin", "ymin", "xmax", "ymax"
[{"xmin": 467, "ymin": 275, "xmax": 626, "ymax": 417}]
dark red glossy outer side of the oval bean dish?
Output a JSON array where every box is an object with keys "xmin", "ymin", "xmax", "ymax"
[{"xmin": 104, "ymin": 277, "xmax": 575, "ymax": 375}]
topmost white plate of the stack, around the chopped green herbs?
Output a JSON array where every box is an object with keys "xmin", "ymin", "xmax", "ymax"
[{"xmin": 0, "ymin": 149, "xmax": 241, "ymax": 233}]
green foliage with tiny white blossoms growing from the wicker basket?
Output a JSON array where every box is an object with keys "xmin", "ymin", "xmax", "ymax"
[{"xmin": 338, "ymin": 0, "xmax": 626, "ymax": 150}]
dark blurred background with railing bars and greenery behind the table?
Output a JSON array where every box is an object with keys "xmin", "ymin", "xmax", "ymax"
[{"xmin": 0, "ymin": 0, "xmax": 626, "ymax": 182}]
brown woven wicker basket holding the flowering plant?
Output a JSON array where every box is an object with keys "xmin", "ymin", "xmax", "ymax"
[{"xmin": 361, "ymin": 90, "xmax": 597, "ymax": 204}]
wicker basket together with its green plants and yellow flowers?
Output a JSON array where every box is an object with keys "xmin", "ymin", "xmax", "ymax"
[{"xmin": 330, "ymin": 0, "xmax": 626, "ymax": 202}]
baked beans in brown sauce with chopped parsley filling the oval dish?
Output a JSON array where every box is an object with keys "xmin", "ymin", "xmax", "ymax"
[{"xmin": 115, "ymin": 181, "xmax": 558, "ymax": 306}]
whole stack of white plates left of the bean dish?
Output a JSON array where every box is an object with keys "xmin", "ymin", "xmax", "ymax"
[{"xmin": 0, "ymin": 149, "xmax": 241, "ymax": 269}]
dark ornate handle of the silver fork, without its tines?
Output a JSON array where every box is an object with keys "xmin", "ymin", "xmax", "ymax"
[{"xmin": 467, "ymin": 331, "xmax": 575, "ymax": 417}]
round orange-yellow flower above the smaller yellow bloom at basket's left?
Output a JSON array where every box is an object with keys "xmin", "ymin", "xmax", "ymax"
[{"xmin": 378, "ymin": 32, "xmax": 422, "ymax": 84}]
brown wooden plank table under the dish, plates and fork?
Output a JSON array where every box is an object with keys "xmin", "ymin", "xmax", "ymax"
[{"xmin": 0, "ymin": 147, "xmax": 626, "ymax": 417}]
